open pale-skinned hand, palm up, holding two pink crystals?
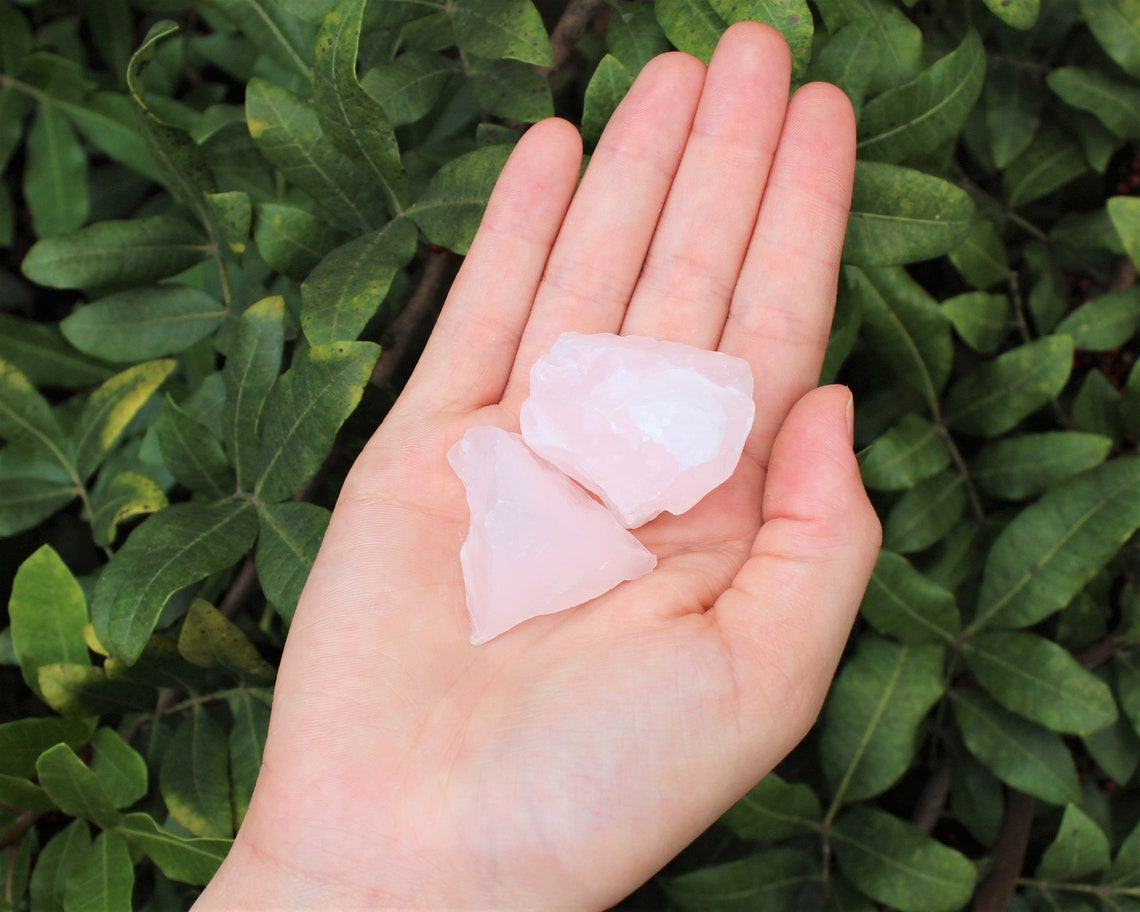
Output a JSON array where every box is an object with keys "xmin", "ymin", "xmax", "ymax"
[{"xmin": 195, "ymin": 23, "xmax": 880, "ymax": 912}]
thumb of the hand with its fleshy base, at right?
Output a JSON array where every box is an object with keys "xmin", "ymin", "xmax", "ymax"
[{"xmin": 714, "ymin": 386, "xmax": 881, "ymax": 761}]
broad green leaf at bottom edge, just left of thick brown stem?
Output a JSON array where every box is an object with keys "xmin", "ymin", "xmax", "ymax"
[{"xmin": 831, "ymin": 807, "xmax": 977, "ymax": 912}]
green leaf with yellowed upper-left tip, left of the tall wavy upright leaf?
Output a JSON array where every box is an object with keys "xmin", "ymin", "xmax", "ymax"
[{"xmin": 245, "ymin": 78, "xmax": 384, "ymax": 231}]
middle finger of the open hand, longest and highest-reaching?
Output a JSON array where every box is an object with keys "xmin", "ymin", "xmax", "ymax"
[{"xmin": 621, "ymin": 23, "xmax": 791, "ymax": 348}]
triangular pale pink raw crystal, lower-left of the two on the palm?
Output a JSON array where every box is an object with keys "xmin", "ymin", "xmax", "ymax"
[{"xmin": 447, "ymin": 428, "xmax": 657, "ymax": 644}]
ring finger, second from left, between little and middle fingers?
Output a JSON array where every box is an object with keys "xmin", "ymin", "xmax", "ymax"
[{"xmin": 506, "ymin": 54, "xmax": 705, "ymax": 401}]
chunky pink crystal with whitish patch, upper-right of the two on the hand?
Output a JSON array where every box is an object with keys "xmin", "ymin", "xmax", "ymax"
[{"xmin": 520, "ymin": 333, "xmax": 756, "ymax": 529}]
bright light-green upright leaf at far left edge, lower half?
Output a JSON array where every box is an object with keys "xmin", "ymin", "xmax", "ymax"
[{"xmin": 8, "ymin": 545, "xmax": 91, "ymax": 698}]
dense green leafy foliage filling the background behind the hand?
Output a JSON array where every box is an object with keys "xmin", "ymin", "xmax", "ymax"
[{"xmin": 0, "ymin": 0, "xmax": 1140, "ymax": 912}]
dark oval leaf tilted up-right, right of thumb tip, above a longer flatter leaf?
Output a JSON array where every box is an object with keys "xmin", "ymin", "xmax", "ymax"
[{"xmin": 945, "ymin": 335, "xmax": 1073, "ymax": 437}]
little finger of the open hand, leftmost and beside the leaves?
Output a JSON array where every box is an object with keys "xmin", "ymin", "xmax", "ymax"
[{"xmin": 398, "ymin": 120, "xmax": 581, "ymax": 413}]
